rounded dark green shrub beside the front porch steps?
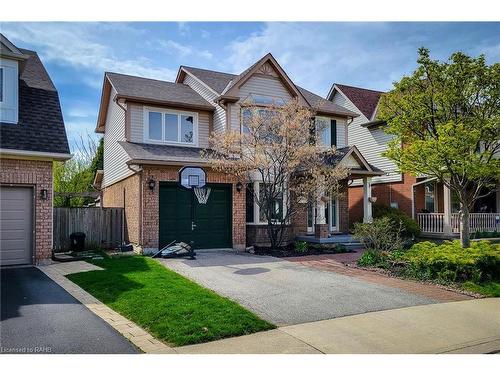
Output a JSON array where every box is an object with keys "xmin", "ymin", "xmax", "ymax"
[{"xmin": 354, "ymin": 216, "xmax": 403, "ymax": 252}]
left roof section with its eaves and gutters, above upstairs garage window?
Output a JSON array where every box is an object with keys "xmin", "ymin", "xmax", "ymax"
[{"xmin": 96, "ymin": 72, "xmax": 215, "ymax": 133}]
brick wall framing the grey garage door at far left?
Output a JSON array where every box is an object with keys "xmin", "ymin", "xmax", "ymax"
[{"xmin": 0, "ymin": 159, "xmax": 53, "ymax": 264}]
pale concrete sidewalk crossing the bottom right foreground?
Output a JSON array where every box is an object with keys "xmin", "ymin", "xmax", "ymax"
[{"xmin": 175, "ymin": 298, "xmax": 500, "ymax": 354}]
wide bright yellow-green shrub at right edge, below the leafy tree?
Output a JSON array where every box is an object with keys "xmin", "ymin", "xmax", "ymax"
[{"xmin": 402, "ymin": 241, "xmax": 500, "ymax": 282}]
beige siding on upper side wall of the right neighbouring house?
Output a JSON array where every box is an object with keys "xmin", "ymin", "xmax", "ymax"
[{"xmin": 333, "ymin": 92, "xmax": 401, "ymax": 186}]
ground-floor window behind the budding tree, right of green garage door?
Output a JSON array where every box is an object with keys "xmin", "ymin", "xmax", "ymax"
[{"xmin": 246, "ymin": 181, "xmax": 287, "ymax": 224}]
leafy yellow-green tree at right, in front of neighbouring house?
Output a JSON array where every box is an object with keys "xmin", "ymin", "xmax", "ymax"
[{"xmin": 378, "ymin": 48, "xmax": 500, "ymax": 247}]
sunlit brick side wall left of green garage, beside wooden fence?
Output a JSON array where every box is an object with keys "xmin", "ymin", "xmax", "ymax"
[{"xmin": 102, "ymin": 174, "xmax": 141, "ymax": 245}]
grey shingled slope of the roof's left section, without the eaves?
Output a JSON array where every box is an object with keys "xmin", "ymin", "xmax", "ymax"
[{"xmin": 106, "ymin": 72, "xmax": 214, "ymax": 110}]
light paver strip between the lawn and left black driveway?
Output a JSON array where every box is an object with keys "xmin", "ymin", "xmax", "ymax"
[{"xmin": 38, "ymin": 261, "xmax": 176, "ymax": 354}]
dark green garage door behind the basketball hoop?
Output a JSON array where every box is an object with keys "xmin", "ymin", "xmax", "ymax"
[{"xmin": 159, "ymin": 182, "xmax": 232, "ymax": 249}]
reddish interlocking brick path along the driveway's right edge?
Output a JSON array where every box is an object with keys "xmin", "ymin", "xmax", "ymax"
[{"xmin": 286, "ymin": 253, "xmax": 473, "ymax": 302}]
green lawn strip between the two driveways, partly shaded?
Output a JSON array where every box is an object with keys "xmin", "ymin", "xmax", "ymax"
[{"xmin": 67, "ymin": 256, "xmax": 274, "ymax": 346}]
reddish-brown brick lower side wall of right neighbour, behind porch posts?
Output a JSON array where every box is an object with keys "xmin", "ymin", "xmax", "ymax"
[{"xmin": 349, "ymin": 173, "xmax": 417, "ymax": 225}]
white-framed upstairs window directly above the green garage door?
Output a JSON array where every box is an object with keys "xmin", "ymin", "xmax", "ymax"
[{"xmin": 144, "ymin": 108, "xmax": 198, "ymax": 146}]
